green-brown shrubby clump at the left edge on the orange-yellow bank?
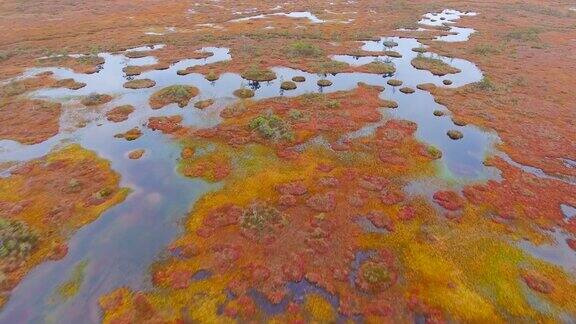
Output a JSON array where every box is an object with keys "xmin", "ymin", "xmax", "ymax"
[{"xmin": 0, "ymin": 216, "xmax": 38, "ymax": 260}]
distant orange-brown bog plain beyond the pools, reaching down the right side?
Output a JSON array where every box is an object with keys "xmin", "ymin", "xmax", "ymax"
[{"xmin": 0, "ymin": 0, "xmax": 576, "ymax": 176}]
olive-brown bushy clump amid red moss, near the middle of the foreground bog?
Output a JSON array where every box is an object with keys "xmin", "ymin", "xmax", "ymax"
[{"xmin": 240, "ymin": 203, "xmax": 286, "ymax": 232}]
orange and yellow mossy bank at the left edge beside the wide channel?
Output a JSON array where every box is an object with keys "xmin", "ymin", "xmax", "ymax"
[{"xmin": 0, "ymin": 145, "xmax": 128, "ymax": 304}]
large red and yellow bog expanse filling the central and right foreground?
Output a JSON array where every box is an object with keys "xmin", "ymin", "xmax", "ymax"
[{"xmin": 100, "ymin": 84, "xmax": 576, "ymax": 323}]
